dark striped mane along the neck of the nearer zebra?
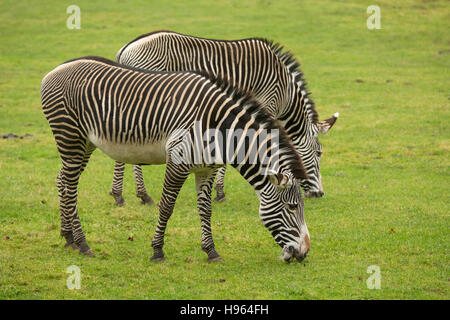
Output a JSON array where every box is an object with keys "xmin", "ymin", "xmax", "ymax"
[{"xmin": 192, "ymin": 71, "xmax": 308, "ymax": 179}]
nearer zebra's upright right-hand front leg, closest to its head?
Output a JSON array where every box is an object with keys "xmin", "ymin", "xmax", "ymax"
[{"xmin": 195, "ymin": 168, "xmax": 222, "ymax": 262}]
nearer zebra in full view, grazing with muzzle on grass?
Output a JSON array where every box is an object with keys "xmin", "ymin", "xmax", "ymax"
[{"xmin": 41, "ymin": 57, "xmax": 310, "ymax": 261}]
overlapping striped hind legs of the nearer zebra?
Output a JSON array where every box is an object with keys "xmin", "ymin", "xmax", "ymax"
[{"xmin": 57, "ymin": 142, "xmax": 95, "ymax": 256}]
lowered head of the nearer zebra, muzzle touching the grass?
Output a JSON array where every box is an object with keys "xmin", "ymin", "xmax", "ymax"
[{"xmin": 259, "ymin": 171, "xmax": 310, "ymax": 262}]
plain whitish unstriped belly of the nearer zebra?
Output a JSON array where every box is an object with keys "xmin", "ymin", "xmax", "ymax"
[{"xmin": 89, "ymin": 135, "xmax": 166, "ymax": 164}]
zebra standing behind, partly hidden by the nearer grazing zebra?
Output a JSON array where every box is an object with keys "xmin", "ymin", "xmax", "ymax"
[{"xmin": 110, "ymin": 31, "xmax": 339, "ymax": 205}]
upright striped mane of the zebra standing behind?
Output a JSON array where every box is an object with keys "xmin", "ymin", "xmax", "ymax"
[{"xmin": 255, "ymin": 38, "xmax": 319, "ymax": 124}]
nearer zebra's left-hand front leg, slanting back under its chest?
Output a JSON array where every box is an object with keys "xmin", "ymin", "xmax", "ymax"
[{"xmin": 150, "ymin": 162, "xmax": 189, "ymax": 261}]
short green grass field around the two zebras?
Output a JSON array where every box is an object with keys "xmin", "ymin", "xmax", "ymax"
[{"xmin": 0, "ymin": 0, "xmax": 450, "ymax": 299}]
